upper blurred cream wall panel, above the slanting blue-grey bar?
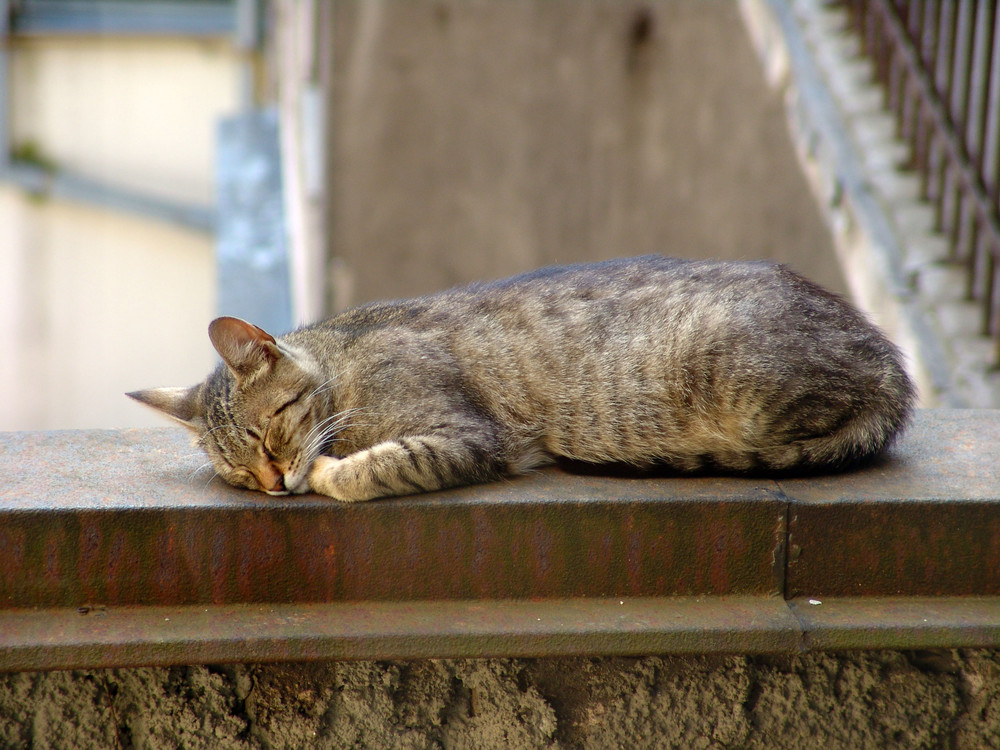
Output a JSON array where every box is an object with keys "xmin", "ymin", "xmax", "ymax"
[{"xmin": 10, "ymin": 37, "xmax": 239, "ymax": 203}]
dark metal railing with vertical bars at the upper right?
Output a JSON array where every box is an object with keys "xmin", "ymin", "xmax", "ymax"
[{"xmin": 840, "ymin": 0, "xmax": 1000, "ymax": 366}]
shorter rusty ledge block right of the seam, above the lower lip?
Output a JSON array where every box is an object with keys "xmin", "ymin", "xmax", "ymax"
[{"xmin": 780, "ymin": 410, "xmax": 1000, "ymax": 598}]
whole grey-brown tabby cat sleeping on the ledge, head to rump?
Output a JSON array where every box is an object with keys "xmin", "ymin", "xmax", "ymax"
[{"xmin": 128, "ymin": 256, "xmax": 914, "ymax": 501}]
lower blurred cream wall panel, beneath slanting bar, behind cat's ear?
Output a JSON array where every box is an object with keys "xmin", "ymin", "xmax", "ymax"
[{"xmin": 0, "ymin": 189, "xmax": 215, "ymax": 430}]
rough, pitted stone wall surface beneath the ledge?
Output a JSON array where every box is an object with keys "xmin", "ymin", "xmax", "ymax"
[{"xmin": 0, "ymin": 651, "xmax": 1000, "ymax": 750}]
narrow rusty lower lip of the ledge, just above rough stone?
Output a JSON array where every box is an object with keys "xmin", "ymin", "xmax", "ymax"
[{"xmin": 0, "ymin": 597, "xmax": 1000, "ymax": 672}]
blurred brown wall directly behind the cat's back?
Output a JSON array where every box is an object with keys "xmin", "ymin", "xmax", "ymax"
[{"xmin": 329, "ymin": 0, "xmax": 843, "ymax": 306}]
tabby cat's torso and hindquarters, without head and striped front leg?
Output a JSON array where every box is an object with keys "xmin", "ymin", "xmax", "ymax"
[{"xmin": 296, "ymin": 256, "xmax": 913, "ymax": 469}]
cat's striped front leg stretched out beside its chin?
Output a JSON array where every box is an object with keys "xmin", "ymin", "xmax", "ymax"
[{"xmin": 309, "ymin": 435, "xmax": 506, "ymax": 502}]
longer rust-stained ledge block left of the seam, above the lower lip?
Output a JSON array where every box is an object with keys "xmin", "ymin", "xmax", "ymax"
[{"xmin": 0, "ymin": 429, "xmax": 786, "ymax": 607}]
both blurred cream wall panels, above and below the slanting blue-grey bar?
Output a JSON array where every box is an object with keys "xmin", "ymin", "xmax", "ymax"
[{"xmin": 0, "ymin": 37, "xmax": 239, "ymax": 430}]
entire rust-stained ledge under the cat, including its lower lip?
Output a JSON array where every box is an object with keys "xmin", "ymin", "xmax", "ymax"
[{"xmin": 0, "ymin": 410, "xmax": 1000, "ymax": 670}]
